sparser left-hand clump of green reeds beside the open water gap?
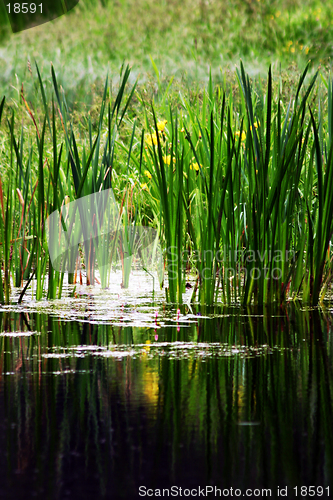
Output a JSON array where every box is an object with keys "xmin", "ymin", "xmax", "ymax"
[{"xmin": 0, "ymin": 65, "xmax": 135, "ymax": 303}]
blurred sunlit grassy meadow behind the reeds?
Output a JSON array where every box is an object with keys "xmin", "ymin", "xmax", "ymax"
[{"xmin": 0, "ymin": 0, "xmax": 333, "ymax": 100}]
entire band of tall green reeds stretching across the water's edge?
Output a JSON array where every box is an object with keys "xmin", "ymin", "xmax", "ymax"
[{"xmin": 0, "ymin": 64, "xmax": 333, "ymax": 305}]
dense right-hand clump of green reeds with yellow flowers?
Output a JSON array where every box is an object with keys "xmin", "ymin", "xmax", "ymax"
[{"xmin": 140, "ymin": 64, "xmax": 332, "ymax": 304}]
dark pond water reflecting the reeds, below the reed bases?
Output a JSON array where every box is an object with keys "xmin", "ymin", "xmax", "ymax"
[{"xmin": 0, "ymin": 307, "xmax": 333, "ymax": 500}]
